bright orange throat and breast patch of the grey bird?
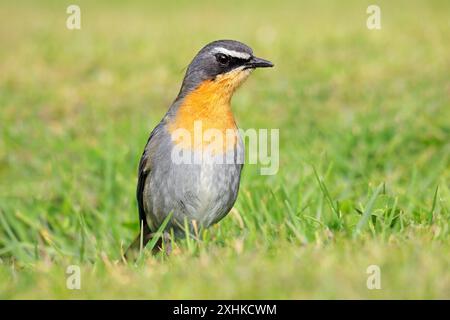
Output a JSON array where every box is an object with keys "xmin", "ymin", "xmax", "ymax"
[{"xmin": 169, "ymin": 75, "xmax": 246, "ymax": 153}]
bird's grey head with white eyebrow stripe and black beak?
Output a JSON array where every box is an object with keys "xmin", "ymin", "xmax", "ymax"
[{"xmin": 178, "ymin": 40, "xmax": 273, "ymax": 96}]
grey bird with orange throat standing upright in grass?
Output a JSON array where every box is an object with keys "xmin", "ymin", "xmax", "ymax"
[{"xmin": 124, "ymin": 40, "xmax": 274, "ymax": 260}]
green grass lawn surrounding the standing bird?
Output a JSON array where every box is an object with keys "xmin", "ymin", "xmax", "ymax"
[{"xmin": 0, "ymin": 1, "xmax": 450, "ymax": 299}]
